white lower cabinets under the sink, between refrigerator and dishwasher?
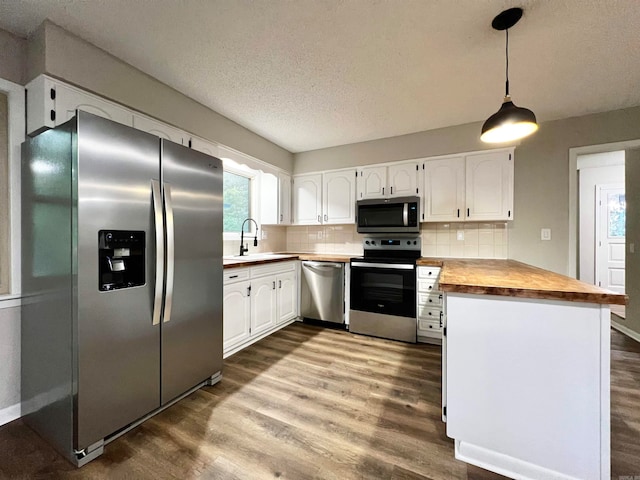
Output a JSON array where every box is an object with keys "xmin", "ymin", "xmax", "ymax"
[{"xmin": 222, "ymin": 262, "xmax": 298, "ymax": 356}]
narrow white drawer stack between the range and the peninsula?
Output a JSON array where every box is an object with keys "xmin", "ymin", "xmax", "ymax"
[{"xmin": 416, "ymin": 267, "xmax": 444, "ymax": 343}]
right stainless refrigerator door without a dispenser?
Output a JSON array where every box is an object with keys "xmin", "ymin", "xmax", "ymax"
[{"xmin": 161, "ymin": 140, "xmax": 222, "ymax": 404}]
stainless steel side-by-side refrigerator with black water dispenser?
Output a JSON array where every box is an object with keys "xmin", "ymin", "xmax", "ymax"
[{"xmin": 21, "ymin": 111, "xmax": 222, "ymax": 466}]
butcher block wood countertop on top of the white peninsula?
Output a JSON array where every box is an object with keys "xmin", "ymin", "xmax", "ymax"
[{"xmin": 430, "ymin": 258, "xmax": 626, "ymax": 305}]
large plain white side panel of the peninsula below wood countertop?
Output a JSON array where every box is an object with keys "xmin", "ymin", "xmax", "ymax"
[{"xmin": 446, "ymin": 294, "xmax": 609, "ymax": 479}]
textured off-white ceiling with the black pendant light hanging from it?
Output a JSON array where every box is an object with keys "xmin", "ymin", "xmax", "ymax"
[{"xmin": 0, "ymin": 0, "xmax": 640, "ymax": 152}]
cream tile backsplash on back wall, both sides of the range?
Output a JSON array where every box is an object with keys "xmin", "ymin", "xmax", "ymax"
[{"xmin": 284, "ymin": 222, "xmax": 509, "ymax": 258}]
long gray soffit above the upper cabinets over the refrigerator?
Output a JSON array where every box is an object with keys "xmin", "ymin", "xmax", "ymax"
[{"xmin": 27, "ymin": 21, "xmax": 293, "ymax": 172}]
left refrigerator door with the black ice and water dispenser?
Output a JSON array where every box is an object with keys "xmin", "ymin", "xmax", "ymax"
[{"xmin": 75, "ymin": 112, "xmax": 162, "ymax": 450}]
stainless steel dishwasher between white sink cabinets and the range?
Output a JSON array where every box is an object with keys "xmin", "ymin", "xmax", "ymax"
[{"xmin": 300, "ymin": 261, "xmax": 344, "ymax": 323}]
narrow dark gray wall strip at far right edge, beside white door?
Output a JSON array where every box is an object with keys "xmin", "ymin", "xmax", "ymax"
[{"xmin": 619, "ymin": 149, "xmax": 640, "ymax": 336}]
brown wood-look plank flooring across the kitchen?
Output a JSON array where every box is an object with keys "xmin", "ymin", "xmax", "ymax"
[{"xmin": 0, "ymin": 323, "xmax": 640, "ymax": 480}]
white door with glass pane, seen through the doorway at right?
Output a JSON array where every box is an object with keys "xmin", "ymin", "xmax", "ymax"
[{"xmin": 596, "ymin": 185, "xmax": 627, "ymax": 293}]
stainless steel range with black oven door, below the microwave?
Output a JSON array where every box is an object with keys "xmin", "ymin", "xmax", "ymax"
[{"xmin": 349, "ymin": 235, "xmax": 421, "ymax": 342}]
